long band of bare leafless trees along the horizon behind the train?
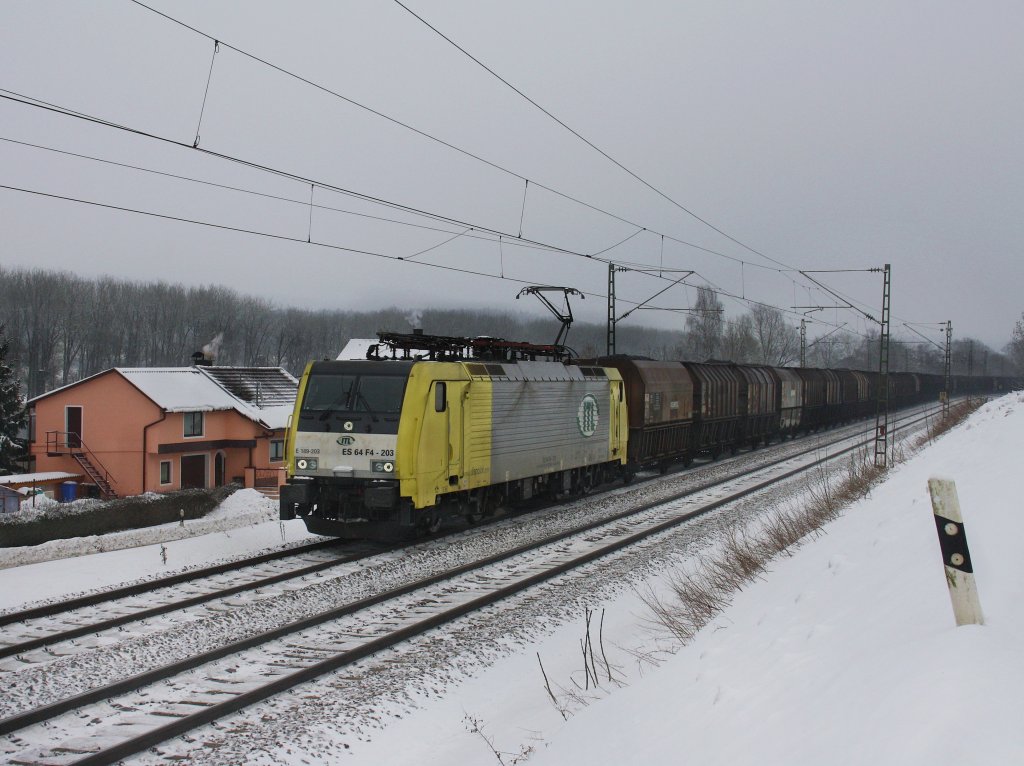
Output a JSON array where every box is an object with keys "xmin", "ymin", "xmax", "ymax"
[{"xmin": 0, "ymin": 267, "xmax": 1010, "ymax": 397}]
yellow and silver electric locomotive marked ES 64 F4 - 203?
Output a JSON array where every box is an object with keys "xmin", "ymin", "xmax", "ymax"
[{"xmin": 281, "ymin": 333, "xmax": 628, "ymax": 538}]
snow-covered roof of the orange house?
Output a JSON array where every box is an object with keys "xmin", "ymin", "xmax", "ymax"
[{"xmin": 30, "ymin": 366, "xmax": 298, "ymax": 430}]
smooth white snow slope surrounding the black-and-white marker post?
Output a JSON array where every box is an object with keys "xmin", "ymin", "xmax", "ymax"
[{"xmin": 520, "ymin": 394, "xmax": 1024, "ymax": 766}]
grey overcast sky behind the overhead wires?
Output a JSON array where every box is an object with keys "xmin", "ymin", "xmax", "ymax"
[{"xmin": 0, "ymin": 0, "xmax": 1024, "ymax": 349}]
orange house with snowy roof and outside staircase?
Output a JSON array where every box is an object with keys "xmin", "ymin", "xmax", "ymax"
[{"xmin": 29, "ymin": 365, "xmax": 297, "ymax": 497}]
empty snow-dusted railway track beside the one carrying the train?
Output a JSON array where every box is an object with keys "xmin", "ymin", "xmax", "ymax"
[{"xmin": 0, "ymin": 403, "xmax": 942, "ymax": 764}]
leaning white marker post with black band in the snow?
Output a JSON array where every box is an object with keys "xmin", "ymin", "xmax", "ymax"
[{"xmin": 928, "ymin": 478, "xmax": 985, "ymax": 627}]
